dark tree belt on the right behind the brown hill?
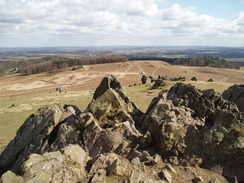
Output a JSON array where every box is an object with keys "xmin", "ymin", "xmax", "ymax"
[{"xmin": 173, "ymin": 56, "xmax": 240, "ymax": 69}]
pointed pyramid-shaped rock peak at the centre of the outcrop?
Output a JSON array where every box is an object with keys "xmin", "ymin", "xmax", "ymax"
[{"xmin": 88, "ymin": 75, "xmax": 139, "ymax": 122}]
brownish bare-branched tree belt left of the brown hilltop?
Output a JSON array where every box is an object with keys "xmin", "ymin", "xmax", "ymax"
[{"xmin": 19, "ymin": 56, "xmax": 128, "ymax": 75}]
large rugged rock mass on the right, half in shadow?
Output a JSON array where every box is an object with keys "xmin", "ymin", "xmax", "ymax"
[{"xmin": 139, "ymin": 83, "xmax": 244, "ymax": 180}]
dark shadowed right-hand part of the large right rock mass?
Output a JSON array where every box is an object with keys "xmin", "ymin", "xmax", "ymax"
[{"xmin": 167, "ymin": 83, "xmax": 244, "ymax": 181}]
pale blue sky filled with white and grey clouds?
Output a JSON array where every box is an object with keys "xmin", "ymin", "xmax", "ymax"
[{"xmin": 0, "ymin": 0, "xmax": 244, "ymax": 47}]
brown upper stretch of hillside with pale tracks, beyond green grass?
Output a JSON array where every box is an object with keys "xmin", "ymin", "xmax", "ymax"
[{"xmin": 0, "ymin": 61, "xmax": 244, "ymax": 98}]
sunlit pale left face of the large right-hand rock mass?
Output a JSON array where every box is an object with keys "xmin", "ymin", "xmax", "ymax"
[{"xmin": 139, "ymin": 93, "xmax": 204, "ymax": 165}]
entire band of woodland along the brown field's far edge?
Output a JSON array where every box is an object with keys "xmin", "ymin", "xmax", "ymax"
[{"xmin": 0, "ymin": 56, "xmax": 240, "ymax": 76}]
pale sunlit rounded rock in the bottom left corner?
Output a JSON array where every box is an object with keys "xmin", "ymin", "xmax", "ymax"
[{"xmin": 5, "ymin": 145, "xmax": 87, "ymax": 183}]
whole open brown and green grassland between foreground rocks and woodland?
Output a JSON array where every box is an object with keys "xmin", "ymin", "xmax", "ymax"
[{"xmin": 0, "ymin": 61, "xmax": 244, "ymax": 152}]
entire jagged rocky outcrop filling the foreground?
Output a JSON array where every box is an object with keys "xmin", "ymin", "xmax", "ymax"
[{"xmin": 0, "ymin": 76, "xmax": 244, "ymax": 183}]
